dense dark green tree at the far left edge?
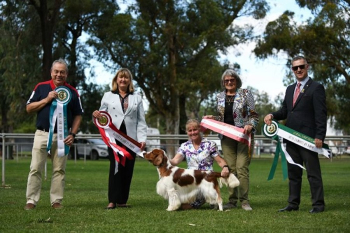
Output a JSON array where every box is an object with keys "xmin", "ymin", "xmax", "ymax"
[{"xmin": 0, "ymin": 1, "xmax": 41, "ymax": 132}]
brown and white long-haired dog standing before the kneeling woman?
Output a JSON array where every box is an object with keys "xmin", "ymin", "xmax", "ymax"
[{"xmin": 144, "ymin": 149, "xmax": 239, "ymax": 211}]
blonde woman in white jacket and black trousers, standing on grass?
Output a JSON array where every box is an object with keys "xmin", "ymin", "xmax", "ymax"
[{"xmin": 92, "ymin": 68, "xmax": 147, "ymax": 209}]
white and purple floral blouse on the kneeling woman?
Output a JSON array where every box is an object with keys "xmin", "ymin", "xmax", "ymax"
[{"xmin": 177, "ymin": 138, "xmax": 220, "ymax": 171}]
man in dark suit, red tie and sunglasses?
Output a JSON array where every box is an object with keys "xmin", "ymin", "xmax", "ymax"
[{"xmin": 264, "ymin": 56, "xmax": 327, "ymax": 213}]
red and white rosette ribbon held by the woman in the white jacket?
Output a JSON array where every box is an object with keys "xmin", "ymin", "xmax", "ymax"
[{"xmin": 94, "ymin": 111, "xmax": 143, "ymax": 173}]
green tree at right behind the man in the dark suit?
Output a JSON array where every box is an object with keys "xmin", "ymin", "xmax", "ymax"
[{"xmin": 254, "ymin": 0, "xmax": 350, "ymax": 132}]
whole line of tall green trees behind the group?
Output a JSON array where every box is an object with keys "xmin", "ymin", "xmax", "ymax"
[{"xmin": 0, "ymin": 0, "xmax": 350, "ymax": 140}]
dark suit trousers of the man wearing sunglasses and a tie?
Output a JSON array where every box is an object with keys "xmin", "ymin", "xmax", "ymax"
[{"xmin": 287, "ymin": 142, "xmax": 325, "ymax": 209}]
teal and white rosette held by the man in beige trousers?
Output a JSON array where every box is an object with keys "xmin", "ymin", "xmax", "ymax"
[{"xmin": 47, "ymin": 86, "xmax": 72, "ymax": 157}]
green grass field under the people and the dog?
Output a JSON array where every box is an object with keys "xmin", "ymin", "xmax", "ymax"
[{"xmin": 0, "ymin": 156, "xmax": 350, "ymax": 233}]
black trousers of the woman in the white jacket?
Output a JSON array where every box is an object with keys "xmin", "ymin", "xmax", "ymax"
[{"xmin": 108, "ymin": 147, "xmax": 135, "ymax": 204}]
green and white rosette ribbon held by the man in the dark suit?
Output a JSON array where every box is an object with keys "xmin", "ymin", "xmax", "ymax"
[{"xmin": 262, "ymin": 121, "xmax": 332, "ymax": 180}]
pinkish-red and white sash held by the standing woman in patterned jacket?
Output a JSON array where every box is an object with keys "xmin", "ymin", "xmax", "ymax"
[{"xmin": 200, "ymin": 119, "xmax": 251, "ymax": 156}]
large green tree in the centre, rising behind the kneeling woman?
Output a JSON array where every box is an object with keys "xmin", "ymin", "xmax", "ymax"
[{"xmin": 90, "ymin": 0, "xmax": 268, "ymax": 137}]
